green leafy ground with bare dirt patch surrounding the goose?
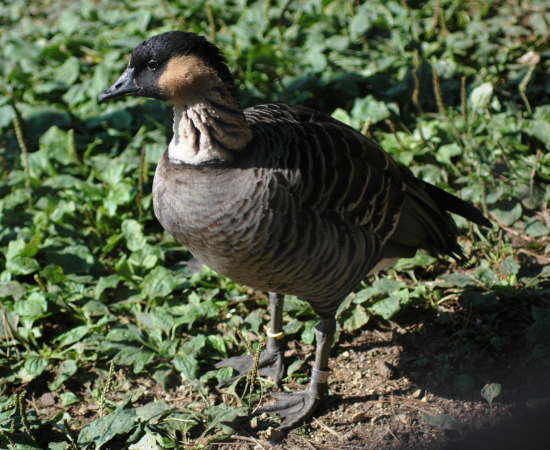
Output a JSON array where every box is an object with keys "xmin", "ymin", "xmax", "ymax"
[{"xmin": 0, "ymin": 0, "xmax": 550, "ymax": 450}]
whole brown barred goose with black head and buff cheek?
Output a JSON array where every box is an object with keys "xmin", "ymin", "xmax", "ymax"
[{"xmin": 100, "ymin": 31, "xmax": 490, "ymax": 429}]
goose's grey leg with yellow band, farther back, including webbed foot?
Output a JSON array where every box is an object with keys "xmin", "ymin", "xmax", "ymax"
[{"xmin": 216, "ymin": 292, "xmax": 285, "ymax": 386}]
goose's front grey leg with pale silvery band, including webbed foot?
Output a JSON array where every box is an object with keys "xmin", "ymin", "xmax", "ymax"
[{"xmin": 257, "ymin": 318, "xmax": 336, "ymax": 430}]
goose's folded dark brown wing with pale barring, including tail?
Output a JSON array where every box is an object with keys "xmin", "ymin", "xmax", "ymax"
[{"xmin": 245, "ymin": 104, "xmax": 490, "ymax": 258}]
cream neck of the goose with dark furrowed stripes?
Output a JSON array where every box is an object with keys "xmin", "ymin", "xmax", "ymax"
[{"xmin": 168, "ymin": 89, "xmax": 252, "ymax": 165}]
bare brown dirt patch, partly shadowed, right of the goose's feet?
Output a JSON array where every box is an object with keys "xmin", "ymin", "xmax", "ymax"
[{"xmin": 209, "ymin": 298, "xmax": 550, "ymax": 450}]
